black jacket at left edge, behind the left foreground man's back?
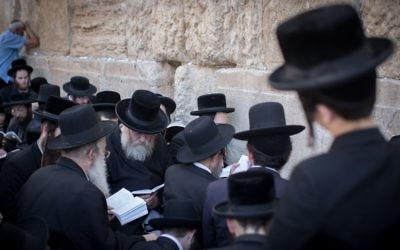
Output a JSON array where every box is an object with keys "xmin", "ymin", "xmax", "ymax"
[{"xmin": 0, "ymin": 142, "xmax": 42, "ymax": 222}]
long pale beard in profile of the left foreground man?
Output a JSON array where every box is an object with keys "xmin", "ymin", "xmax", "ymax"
[{"xmin": 87, "ymin": 156, "xmax": 110, "ymax": 198}]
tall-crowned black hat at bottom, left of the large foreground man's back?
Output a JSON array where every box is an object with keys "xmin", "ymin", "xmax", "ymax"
[{"xmin": 213, "ymin": 169, "xmax": 275, "ymax": 219}]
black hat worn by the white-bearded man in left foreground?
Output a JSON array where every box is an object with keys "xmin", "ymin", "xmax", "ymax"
[{"xmin": 48, "ymin": 104, "xmax": 117, "ymax": 149}]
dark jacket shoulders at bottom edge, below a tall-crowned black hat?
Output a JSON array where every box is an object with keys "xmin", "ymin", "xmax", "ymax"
[{"xmin": 208, "ymin": 234, "xmax": 267, "ymax": 250}]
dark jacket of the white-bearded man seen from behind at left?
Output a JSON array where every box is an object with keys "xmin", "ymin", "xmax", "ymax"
[{"xmin": 17, "ymin": 157, "xmax": 144, "ymax": 249}]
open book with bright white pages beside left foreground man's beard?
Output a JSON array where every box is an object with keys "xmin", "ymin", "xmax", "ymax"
[{"xmin": 107, "ymin": 188, "xmax": 149, "ymax": 225}]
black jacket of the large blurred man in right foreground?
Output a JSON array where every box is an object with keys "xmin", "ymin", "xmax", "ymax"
[{"xmin": 269, "ymin": 128, "xmax": 400, "ymax": 250}]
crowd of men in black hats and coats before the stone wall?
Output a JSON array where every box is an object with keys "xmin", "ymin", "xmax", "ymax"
[{"xmin": 0, "ymin": 5, "xmax": 400, "ymax": 250}]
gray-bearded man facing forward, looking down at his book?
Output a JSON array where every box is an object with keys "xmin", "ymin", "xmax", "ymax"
[{"xmin": 107, "ymin": 90, "xmax": 171, "ymax": 234}]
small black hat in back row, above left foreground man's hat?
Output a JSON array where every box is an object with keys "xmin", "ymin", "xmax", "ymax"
[{"xmin": 63, "ymin": 76, "xmax": 97, "ymax": 96}]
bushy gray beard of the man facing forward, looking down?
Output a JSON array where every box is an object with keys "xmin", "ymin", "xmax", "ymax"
[{"xmin": 121, "ymin": 132, "xmax": 155, "ymax": 161}]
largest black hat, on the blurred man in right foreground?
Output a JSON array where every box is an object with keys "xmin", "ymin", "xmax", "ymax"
[{"xmin": 269, "ymin": 5, "xmax": 393, "ymax": 90}]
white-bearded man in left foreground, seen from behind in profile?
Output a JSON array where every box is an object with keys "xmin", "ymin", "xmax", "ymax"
[{"xmin": 17, "ymin": 105, "xmax": 144, "ymax": 249}]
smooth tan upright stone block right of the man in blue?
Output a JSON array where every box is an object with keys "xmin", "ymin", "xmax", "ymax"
[{"xmin": 38, "ymin": 0, "xmax": 71, "ymax": 55}]
